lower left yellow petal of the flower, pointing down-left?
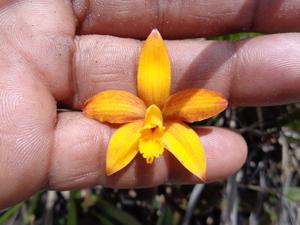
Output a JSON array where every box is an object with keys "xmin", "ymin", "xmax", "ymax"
[{"xmin": 106, "ymin": 120, "xmax": 143, "ymax": 176}]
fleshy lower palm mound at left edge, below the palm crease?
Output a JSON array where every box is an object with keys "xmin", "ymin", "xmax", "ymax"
[{"xmin": 0, "ymin": 62, "xmax": 56, "ymax": 209}]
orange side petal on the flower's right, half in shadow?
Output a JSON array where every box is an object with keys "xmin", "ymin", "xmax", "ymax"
[{"xmin": 163, "ymin": 89, "xmax": 228, "ymax": 122}]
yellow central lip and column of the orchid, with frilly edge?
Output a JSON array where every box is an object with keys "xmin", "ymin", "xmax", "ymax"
[{"xmin": 139, "ymin": 105, "xmax": 165, "ymax": 164}]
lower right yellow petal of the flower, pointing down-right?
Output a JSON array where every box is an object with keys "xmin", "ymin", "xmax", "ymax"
[{"xmin": 161, "ymin": 122, "xmax": 206, "ymax": 181}]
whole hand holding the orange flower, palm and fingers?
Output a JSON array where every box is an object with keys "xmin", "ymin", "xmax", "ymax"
[{"xmin": 0, "ymin": 0, "xmax": 300, "ymax": 208}]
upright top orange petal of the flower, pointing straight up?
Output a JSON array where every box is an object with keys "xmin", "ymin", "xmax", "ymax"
[{"xmin": 137, "ymin": 29, "xmax": 171, "ymax": 107}]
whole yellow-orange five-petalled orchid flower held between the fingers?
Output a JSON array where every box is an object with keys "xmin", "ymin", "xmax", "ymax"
[{"xmin": 83, "ymin": 29, "xmax": 227, "ymax": 181}]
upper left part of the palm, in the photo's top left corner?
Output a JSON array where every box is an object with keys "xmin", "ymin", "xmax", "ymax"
[{"xmin": 0, "ymin": 0, "xmax": 75, "ymax": 99}]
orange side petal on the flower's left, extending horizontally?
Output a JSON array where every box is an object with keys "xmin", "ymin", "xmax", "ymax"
[{"xmin": 82, "ymin": 90, "xmax": 146, "ymax": 123}]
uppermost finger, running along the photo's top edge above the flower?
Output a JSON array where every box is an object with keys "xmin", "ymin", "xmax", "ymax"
[{"xmin": 73, "ymin": 0, "xmax": 300, "ymax": 38}]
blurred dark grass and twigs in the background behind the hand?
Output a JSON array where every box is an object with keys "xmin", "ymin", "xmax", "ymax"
[{"xmin": 0, "ymin": 33, "xmax": 300, "ymax": 225}]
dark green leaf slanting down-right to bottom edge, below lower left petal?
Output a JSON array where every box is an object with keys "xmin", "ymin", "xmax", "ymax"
[{"xmin": 97, "ymin": 199, "xmax": 141, "ymax": 225}]
